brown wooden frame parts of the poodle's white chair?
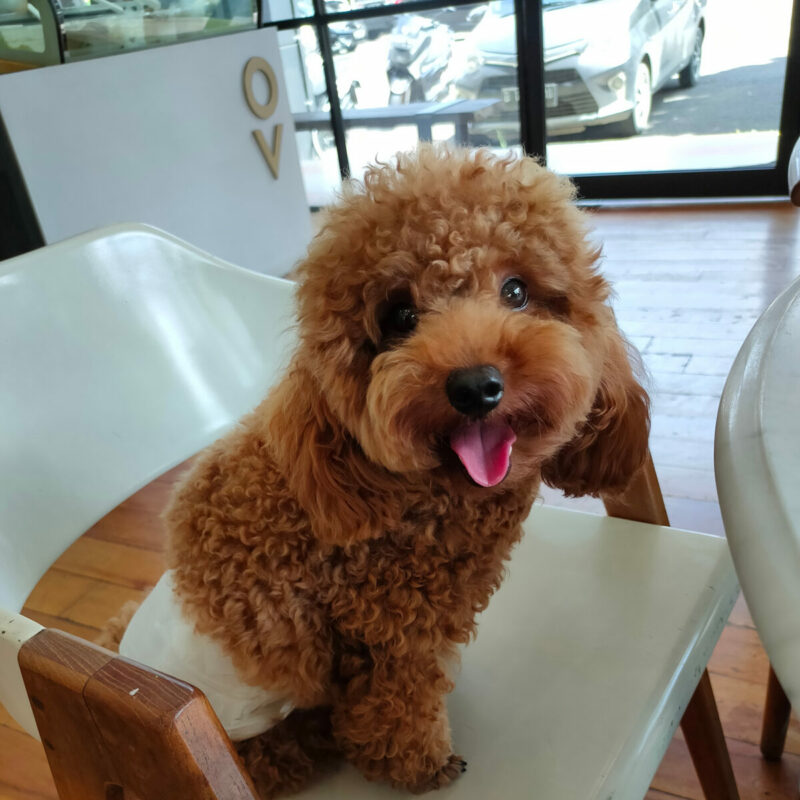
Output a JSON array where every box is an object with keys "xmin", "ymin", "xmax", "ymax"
[{"xmin": 14, "ymin": 455, "xmax": 736, "ymax": 800}]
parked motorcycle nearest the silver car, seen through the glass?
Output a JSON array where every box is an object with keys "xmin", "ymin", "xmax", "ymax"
[{"xmin": 386, "ymin": 14, "xmax": 453, "ymax": 105}]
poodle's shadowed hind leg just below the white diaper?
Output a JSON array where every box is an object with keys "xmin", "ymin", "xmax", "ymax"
[{"xmin": 236, "ymin": 707, "xmax": 339, "ymax": 800}]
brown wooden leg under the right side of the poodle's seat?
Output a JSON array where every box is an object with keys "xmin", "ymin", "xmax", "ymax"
[{"xmin": 681, "ymin": 670, "xmax": 739, "ymax": 800}]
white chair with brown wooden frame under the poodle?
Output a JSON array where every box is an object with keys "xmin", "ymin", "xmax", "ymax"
[{"xmin": 0, "ymin": 226, "xmax": 738, "ymax": 800}]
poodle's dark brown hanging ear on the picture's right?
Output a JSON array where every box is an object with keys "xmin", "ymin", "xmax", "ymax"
[{"xmin": 542, "ymin": 326, "xmax": 650, "ymax": 497}]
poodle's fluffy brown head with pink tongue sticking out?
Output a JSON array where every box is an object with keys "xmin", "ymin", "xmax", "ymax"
[{"xmin": 284, "ymin": 146, "xmax": 648, "ymax": 536}]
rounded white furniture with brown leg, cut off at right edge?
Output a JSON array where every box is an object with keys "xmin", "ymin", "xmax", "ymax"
[{"xmin": 714, "ymin": 272, "xmax": 800, "ymax": 759}]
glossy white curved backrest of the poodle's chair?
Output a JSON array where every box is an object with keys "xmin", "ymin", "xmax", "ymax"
[{"xmin": 0, "ymin": 225, "xmax": 294, "ymax": 611}]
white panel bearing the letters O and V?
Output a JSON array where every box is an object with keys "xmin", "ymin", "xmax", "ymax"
[{"xmin": 0, "ymin": 29, "xmax": 310, "ymax": 275}]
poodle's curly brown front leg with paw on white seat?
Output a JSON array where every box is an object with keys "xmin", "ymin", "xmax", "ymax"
[{"xmin": 332, "ymin": 653, "xmax": 466, "ymax": 793}]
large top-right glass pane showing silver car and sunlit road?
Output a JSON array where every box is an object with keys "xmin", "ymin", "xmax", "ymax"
[{"xmin": 543, "ymin": 0, "xmax": 792, "ymax": 174}]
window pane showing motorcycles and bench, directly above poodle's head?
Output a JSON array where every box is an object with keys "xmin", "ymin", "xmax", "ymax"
[{"xmin": 329, "ymin": 3, "xmax": 519, "ymax": 184}]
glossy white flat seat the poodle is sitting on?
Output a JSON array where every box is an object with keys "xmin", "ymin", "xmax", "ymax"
[{"xmin": 298, "ymin": 506, "xmax": 738, "ymax": 800}]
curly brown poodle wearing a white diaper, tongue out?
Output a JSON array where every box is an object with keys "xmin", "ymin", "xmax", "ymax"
[{"xmin": 112, "ymin": 145, "xmax": 649, "ymax": 797}]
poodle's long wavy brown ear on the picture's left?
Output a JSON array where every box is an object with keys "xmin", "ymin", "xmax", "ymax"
[{"xmin": 267, "ymin": 370, "xmax": 402, "ymax": 546}]
